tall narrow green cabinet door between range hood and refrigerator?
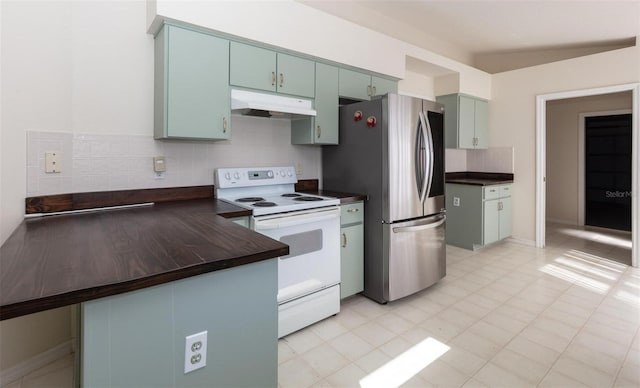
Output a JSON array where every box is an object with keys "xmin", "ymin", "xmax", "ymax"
[{"xmin": 314, "ymin": 63, "xmax": 339, "ymax": 144}]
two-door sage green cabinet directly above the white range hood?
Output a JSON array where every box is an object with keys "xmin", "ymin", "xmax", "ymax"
[{"xmin": 229, "ymin": 42, "xmax": 315, "ymax": 98}]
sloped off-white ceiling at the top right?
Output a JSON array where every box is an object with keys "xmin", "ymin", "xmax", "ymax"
[{"xmin": 301, "ymin": 0, "xmax": 640, "ymax": 73}]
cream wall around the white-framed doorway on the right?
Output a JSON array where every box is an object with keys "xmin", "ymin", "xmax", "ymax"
[{"xmin": 489, "ymin": 47, "xmax": 640, "ymax": 241}]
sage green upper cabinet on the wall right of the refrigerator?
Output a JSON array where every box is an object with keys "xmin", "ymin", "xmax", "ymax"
[{"xmin": 436, "ymin": 94, "xmax": 489, "ymax": 149}]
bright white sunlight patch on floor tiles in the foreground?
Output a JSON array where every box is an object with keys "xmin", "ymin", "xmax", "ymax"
[{"xmin": 360, "ymin": 337, "xmax": 451, "ymax": 388}]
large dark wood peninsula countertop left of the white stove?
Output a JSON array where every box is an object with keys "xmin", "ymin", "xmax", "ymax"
[{"xmin": 0, "ymin": 198, "xmax": 289, "ymax": 320}]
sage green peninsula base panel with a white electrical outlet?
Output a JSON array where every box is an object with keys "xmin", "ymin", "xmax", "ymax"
[{"xmin": 81, "ymin": 259, "xmax": 278, "ymax": 388}]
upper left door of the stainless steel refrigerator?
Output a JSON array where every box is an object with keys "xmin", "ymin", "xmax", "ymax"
[{"xmin": 382, "ymin": 94, "xmax": 431, "ymax": 222}]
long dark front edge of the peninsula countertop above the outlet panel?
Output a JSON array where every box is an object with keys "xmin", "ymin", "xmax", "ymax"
[{"xmin": 0, "ymin": 248, "xmax": 289, "ymax": 321}]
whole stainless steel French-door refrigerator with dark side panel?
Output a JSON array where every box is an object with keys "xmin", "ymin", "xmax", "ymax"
[{"xmin": 322, "ymin": 94, "xmax": 446, "ymax": 303}]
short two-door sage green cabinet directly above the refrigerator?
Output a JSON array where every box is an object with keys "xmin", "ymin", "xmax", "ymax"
[{"xmin": 338, "ymin": 68, "xmax": 398, "ymax": 100}]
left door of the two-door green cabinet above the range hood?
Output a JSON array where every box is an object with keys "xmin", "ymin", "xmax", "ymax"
[{"xmin": 229, "ymin": 42, "xmax": 277, "ymax": 92}]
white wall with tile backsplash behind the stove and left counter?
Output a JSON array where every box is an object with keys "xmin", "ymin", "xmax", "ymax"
[{"xmin": 0, "ymin": 1, "xmax": 321, "ymax": 371}]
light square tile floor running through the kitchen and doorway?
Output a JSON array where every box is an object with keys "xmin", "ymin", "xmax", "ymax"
[{"xmin": 8, "ymin": 224, "xmax": 640, "ymax": 388}]
